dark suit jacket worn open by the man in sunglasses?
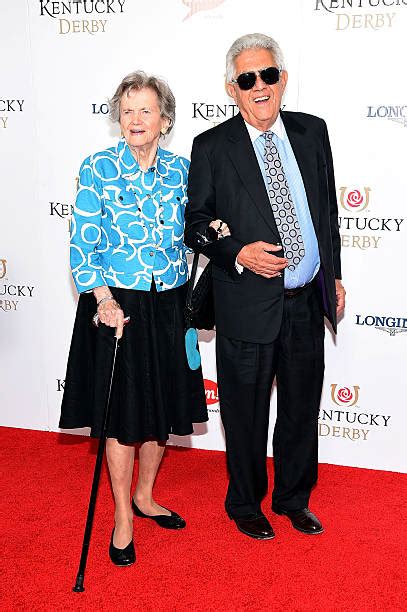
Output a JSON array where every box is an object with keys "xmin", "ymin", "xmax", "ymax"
[{"xmin": 185, "ymin": 112, "xmax": 341, "ymax": 344}]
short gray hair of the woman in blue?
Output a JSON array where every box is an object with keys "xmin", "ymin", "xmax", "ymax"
[{"xmin": 109, "ymin": 70, "xmax": 175, "ymax": 134}]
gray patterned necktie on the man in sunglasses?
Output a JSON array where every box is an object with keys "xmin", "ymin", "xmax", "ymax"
[{"xmin": 264, "ymin": 132, "xmax": 305, "ymax": 271}]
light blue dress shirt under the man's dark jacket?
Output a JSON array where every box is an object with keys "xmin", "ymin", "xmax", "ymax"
[{"xmin": 246, "ymin": 115, "xmax": 320, "ymax": 289}]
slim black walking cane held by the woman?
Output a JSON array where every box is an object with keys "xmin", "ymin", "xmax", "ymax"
[{"xmin": 72, "ymin": 314, "xmax": 130, "ymax": 593}]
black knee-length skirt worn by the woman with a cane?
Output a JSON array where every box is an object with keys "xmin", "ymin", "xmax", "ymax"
[{"xmin": 59, "ymin": 285, "xmax": 208, "ymax": 444}]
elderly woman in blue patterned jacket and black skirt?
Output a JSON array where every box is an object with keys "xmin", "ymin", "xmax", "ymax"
[{"xmin": 60, "ymin": 71, "xmax": 228, "ymax": 565}]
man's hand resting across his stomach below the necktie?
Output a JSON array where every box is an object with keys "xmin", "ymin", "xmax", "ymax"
[{"xmin": 237, "ymin": 241, "xmax": 288, "ymax": 278}]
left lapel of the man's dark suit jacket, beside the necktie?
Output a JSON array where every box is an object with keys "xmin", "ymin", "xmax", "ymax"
[{"xmin": 228, "ymin": 113, "xmax": 278, "ymax": 237}]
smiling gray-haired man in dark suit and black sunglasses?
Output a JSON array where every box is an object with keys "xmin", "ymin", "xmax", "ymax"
[{"xmin": 185, "ymin": 34, "xmax": 345, "ymax": 540}]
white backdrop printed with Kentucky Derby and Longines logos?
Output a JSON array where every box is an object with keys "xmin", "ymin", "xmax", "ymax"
[{"xmin": 0, "ymin": 0, "xmax": 407, "ymax": 471}]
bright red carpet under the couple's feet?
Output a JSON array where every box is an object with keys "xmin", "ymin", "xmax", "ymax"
[{"xmin": 0, "ymin": 428, "xmax": 407, "ymax": 612}]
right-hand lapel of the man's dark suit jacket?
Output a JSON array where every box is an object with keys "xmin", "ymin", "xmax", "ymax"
[{"xmin": 281, "ymin": 112, "xmax": 319, "ymax": 231}]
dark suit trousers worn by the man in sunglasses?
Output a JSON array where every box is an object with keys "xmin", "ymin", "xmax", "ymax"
[{"xmin": 216, "ymin": 282, "xmax": 325, "ymax": 517}]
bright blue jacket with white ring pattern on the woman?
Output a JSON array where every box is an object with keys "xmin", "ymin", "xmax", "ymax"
[{"xmin": 71, "ymin": 139, "xmax": 189, "ymax": 293}]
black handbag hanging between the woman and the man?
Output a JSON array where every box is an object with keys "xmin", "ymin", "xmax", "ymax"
[{"xmin": 185, "ymin": 253, "xmax": 215, "ymax": 330}]
